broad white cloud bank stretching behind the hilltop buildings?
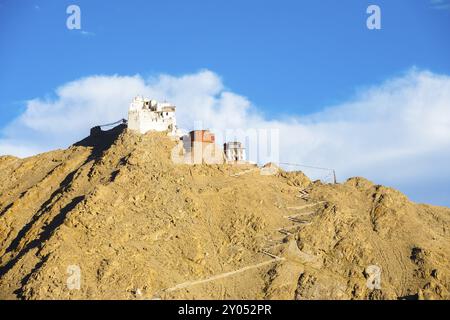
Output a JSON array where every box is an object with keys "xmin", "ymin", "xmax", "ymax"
[{"xmin": 0, "ymin": 70, "xmax": 450, "ymax": 203}]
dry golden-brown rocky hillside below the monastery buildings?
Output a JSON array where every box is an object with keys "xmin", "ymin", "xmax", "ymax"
[{"xmin": 0, "ymin": 127, "xmax": 450, "ymax": 299}]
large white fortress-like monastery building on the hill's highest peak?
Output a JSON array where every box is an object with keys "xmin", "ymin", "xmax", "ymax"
[{"xmin": 128, "ymin": 96, "xmax": 179, "ymax": 136}]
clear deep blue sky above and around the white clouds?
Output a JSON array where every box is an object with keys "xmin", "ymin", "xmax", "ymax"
[{"xmin": 0, "ymin": 0, "xmax": 450, "ymax": 205}]
